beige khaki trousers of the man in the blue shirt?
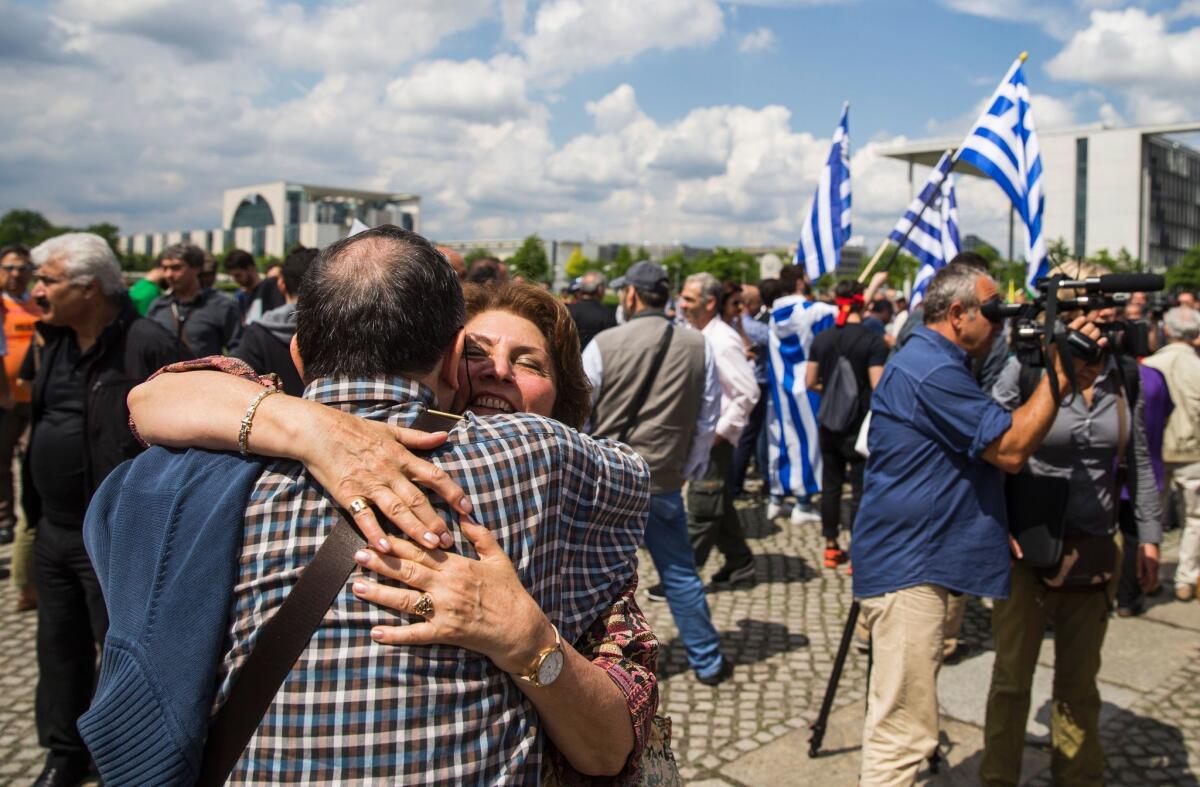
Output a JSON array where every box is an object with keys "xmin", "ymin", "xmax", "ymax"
[{"xmin": 859, "ymin": 584, "xmax": 950, "ymax": 787}]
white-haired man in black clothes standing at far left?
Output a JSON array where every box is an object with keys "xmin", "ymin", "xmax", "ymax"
[{"xmin": 23, "ymin": 233, "xmax": 190, "ymax": 786}]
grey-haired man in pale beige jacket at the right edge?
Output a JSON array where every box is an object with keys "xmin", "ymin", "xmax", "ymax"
[{"xmin": 1145, "ymin": 306, "xmax": 1200, "ymax": 601}]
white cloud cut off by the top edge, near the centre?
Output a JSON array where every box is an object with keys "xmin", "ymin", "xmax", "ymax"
[{"xmin": 521, "ymin": 0, "xmax": 725, "ymax": 84}]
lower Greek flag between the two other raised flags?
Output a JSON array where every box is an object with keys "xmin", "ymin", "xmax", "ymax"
[{"xmin": 888, "ymin": 152, "xmax": 961, "ymax": 308}]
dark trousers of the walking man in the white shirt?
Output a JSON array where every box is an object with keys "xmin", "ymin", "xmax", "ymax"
[{"xmin": 688, "ymin": 440, "xmax": 754, "ymax": 569}]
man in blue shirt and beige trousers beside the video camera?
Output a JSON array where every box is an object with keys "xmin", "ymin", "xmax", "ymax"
[{"xmin": 851, "ymin": 264, "xmax": 1099, "ymax": 785}]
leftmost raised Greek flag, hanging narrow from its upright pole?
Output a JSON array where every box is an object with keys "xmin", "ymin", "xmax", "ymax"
[{"xmin": 792, "ymin": 102, "xmax": 850, "ymax": 282}]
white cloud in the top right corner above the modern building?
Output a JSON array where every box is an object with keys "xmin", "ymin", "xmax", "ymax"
[{"xmin": 1046, "ymin": 8, "xmax": 1200, "ymax": 122}]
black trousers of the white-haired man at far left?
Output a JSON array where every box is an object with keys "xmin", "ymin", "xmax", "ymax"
[{"xmin": 34, "ymin": 517, "xmax": 108, "ymax": 758}]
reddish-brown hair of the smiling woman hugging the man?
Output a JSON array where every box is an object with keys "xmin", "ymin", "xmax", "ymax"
[{"xmin": 462, "ymin": 282, "xmax": 592, "ymax": 429}]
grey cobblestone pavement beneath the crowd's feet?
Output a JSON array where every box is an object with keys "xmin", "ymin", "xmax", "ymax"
[{"xmin": 0, "ymin": 489, "xmax": 1200, "ymax": 787}]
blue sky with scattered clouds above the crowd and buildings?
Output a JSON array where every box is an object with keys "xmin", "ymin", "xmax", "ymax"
[{"xmin": 0, "ymin": 0, "xmax": 1200, "ymax": 246}]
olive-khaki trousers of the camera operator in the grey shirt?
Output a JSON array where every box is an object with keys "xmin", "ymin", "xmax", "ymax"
[{"xmin": 979, "ymin": 559, "xmax": 1121, "ymax": 786}]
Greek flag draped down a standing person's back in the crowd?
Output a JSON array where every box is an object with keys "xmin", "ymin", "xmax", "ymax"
[{"xmin": 767, "ymin": 295, "xmax": 838, "ymax": 498}]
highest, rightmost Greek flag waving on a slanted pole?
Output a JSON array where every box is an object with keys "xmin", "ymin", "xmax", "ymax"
[{"xmin": 955, "ymin": 55, "xmax": 1050, "ymax": 289}]
